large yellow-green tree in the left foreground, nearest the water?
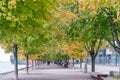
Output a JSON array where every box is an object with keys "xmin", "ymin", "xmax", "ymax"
[{"xmin": 0, "ymin": 0, "xmax": 57, "ymax": 80}]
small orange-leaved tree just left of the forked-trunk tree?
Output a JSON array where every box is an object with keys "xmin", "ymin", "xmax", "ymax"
[{"xmin": 63, "ymin": 41, "xmax": 85, "ymax": 68}]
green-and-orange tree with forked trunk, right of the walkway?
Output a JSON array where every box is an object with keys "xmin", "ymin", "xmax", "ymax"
[{"xmin": 57, "ymin": 0, "xmax": 103, "ymax": 72}]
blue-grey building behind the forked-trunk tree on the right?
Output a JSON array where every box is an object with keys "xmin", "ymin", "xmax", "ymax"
[{"xmin": 88, "ymin": 48, "xmax": 120, "ymax": 66}]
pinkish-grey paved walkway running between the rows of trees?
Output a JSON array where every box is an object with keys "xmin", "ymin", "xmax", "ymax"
[{"xmin": 2, "ymin": 64, "xmax": 92, "ymax": 80}]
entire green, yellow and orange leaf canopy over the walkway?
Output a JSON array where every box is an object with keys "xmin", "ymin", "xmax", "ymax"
[{"xmin": 0, "ymin": 0, "xmax": 120, "ymax": 65}]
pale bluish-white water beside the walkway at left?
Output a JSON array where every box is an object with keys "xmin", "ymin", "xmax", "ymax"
[{"xmin": 0, "ymin": 61, "xmax": 25, "ymax": 74}]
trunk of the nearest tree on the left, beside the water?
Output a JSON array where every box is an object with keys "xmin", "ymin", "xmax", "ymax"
[{"xmin": 13, "ymin": 44, "xmax": 18, "ymax": 80}]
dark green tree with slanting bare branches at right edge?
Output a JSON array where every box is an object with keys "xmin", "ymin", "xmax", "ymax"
[{"xmin": 95, "ymin": 6, "xmax": 120, "ymax": 54}]
